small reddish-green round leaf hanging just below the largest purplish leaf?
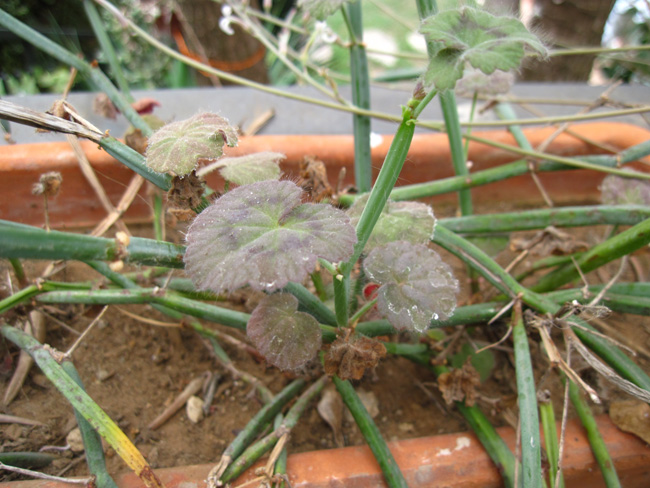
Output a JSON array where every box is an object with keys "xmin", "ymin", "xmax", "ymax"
[{"xmin": 246, "ymin": 293, "xmax": 322, "ymax": 371}]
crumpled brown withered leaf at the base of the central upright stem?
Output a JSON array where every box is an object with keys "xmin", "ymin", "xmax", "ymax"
[{"xmin": 325, "ymin": 335, "xmax": 386, "ymax": 380}]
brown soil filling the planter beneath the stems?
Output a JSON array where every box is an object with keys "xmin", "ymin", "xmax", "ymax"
[{"xmin": 0, "ymin": 219, "xmax": 650, "ymax": 481}]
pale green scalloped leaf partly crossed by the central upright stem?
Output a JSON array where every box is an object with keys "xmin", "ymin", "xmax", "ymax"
[{"xmin": 347, "ymin": 195, "xmax": 436, "ymax": 252}]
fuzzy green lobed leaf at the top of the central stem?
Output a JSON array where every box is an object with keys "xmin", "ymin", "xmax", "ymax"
[{"xmin": 420, "ymin": 6, "xmax": 547, "ymax": 90}]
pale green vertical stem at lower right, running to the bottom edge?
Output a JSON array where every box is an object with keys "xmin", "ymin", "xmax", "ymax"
[{"xmin": 512, "ymin": 303, "xmax": 543, "ymax": 488}]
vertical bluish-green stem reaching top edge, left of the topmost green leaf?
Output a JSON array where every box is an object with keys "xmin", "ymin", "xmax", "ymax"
[{"xmin": 343, "ymin": 0, "xmax": 372, "ymax": 193}]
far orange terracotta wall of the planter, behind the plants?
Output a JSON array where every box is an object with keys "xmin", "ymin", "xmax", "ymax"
[{"xmin": 0, "ymin": 122, "xmax": 650, "ymax": 228}]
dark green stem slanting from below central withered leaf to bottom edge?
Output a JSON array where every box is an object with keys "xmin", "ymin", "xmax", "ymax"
[{"xmin": 334, "ymin": 376, "xmax": 408, "ymax": 488}]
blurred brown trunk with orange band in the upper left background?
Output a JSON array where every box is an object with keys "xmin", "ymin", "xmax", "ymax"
[{"xmin": 173, "ymin": 0, "xmax": 268, "ymax": 85}]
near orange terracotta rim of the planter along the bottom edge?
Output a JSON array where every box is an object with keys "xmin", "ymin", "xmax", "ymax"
[{"xmin": 3, "ymin": 416, "xmax": 650, "ymax": 488}]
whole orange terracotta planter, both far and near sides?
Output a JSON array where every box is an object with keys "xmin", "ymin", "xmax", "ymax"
[{"xmin": 0, "ymin": 123, "xmax": 650, "ymax": 488}]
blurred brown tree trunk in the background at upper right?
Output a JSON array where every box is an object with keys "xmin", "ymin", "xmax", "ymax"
[{"xmin": 520, "ymin": 0, "xmax": 614, "ymax": 81}]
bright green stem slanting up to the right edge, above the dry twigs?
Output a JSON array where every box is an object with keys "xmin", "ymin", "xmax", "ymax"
[{"xmin": 531, "ymin": 218, "xmax": 650, "ymax": 292}]
